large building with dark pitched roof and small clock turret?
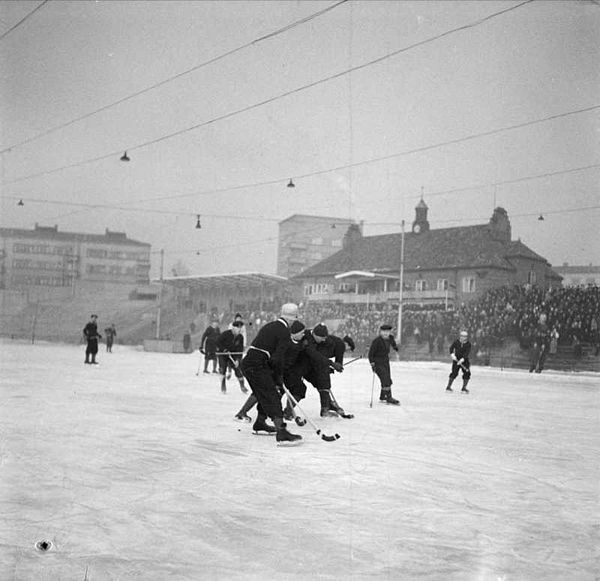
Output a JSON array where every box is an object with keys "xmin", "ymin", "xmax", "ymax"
[{"xmin": 294, "ymin": 200, "xmax": 561, "ymax": 308}]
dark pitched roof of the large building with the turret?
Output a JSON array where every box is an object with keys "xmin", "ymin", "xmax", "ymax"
[{"xmin": 294, "ymin": 224, "xmax": 546, "ymax": 278}]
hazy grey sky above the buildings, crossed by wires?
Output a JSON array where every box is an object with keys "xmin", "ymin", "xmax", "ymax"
[{"xmin": 0, "ymin": 0, "xmax": 600, "ymax": 277}]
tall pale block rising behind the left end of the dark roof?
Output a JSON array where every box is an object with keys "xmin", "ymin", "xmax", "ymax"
[{"xmin": 277, "ymin": 214, "xmax": 354, "ymax": 277}]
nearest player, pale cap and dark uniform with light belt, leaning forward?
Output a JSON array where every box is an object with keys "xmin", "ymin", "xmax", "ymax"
[{"xmin": 242, "ymin": 303, "xmax": 302, "ymax": 443}]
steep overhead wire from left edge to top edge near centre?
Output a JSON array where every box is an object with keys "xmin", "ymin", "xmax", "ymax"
[{"xmin": 0, "ymin": 0, "xmax": 349, "ymax": 153}]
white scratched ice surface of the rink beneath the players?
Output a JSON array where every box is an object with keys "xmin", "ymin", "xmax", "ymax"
[{"xmin": 0, "ymin": 342, "xmax": 600, "ymax": 581}]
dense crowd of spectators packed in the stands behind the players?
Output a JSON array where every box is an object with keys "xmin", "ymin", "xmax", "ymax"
[{"xmin": 198, "ymin": 285, "xmax": 600, "ymax": 357}]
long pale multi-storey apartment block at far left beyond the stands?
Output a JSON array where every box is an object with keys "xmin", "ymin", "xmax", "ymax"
[{"xmin": 0, "ymin": 224, "xmax": 151, "ymax": 290}]
